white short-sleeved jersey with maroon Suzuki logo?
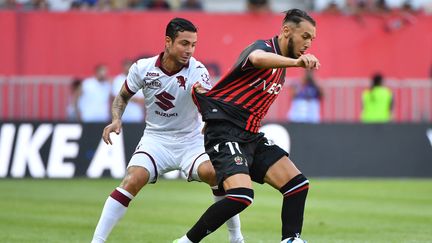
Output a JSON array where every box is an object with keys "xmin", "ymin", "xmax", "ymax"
[{"xmin": 126, "ymin": 53, "xmax": 211, "ymax": 137}]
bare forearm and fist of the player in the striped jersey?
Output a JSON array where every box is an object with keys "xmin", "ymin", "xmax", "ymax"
[{"xmin": 248, "ymin": 50, "xmax": 320, "ymax": 69}]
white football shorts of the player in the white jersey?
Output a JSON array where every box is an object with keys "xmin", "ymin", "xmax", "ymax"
[{"xmin": 128, "ymin": 134, "xmax": 209, "ymax": 183}]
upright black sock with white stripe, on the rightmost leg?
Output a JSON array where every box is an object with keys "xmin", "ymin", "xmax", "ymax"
[{"xmin": 279, "ymin": 174, "xmax": 309, "ymax": 240}]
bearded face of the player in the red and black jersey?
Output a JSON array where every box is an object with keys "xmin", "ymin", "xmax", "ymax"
[{"xmin": 284, "ymin": 21, "xmax": 316, "ymax": 58}]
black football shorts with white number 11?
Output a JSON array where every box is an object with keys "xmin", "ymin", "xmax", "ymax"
[{"xmin": 204, "ymin": 120, "xmax": 289, "ymax": 184}]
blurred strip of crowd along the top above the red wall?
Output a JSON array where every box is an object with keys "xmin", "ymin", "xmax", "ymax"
[{"xmin": 0, "ymin": 0, "xmax": 432, "ymax": 14}]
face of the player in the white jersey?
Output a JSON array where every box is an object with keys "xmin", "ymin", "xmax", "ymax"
[{"xmin": 166, "ymin": 31, "xmax": 197, "ymax": 65}]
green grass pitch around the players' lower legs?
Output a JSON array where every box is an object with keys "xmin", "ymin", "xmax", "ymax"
[{"xmin": 0, "ymin": 178, "xmax": 432, "ymax": 243}]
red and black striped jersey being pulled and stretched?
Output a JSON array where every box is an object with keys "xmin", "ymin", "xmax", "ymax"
[{"xmin": 193, "ymin": 36, "xmax": 285, "ymax": 133}]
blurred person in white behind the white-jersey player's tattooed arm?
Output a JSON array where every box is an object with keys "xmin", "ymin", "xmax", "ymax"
[{"xmin": 111, "ymin": 60, "xmax": 144, "ymax": 122}]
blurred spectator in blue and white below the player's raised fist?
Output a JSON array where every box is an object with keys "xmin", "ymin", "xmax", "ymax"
[{"xmin": 288, "ymin": 70, "xmax": 323, "ymax": 123}]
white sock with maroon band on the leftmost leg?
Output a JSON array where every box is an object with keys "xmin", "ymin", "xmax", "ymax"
[{"xmin": 92, "ymin": 187, "xmax": 134, "ymax": 243}]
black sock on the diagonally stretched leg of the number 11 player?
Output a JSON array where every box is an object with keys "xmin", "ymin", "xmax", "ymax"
[{"xmin": 186, "ymin": 188, "xmax": 254, "ymax": 242}]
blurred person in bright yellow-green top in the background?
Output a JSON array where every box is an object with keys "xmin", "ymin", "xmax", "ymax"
[{"xmin": 361, "ymin": 73, "xmax": 393, "ymax": 123}]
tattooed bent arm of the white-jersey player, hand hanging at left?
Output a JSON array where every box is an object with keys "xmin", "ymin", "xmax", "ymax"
[{"xmin": 102, "ymin": 85, "xmax": 133, "ymax": 144}]
